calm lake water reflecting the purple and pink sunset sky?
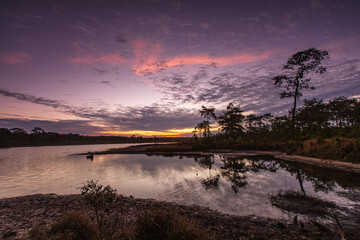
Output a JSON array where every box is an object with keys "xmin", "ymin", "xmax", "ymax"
[{"xmin": 0, "ymin": 144, "xmax": 360, "ymax": 218}]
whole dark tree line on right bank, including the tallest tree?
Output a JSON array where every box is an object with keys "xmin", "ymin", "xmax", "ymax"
[{"xmin": 193, "ymin": 48, "xmax": 360, "ymax": 146}]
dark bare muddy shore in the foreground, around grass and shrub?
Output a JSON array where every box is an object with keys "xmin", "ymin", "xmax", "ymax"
[{"xmin": 0, "ymin": 194, "xmax": 360, "ymax": 239}]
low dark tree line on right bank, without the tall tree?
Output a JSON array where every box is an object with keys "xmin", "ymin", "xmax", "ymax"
[{"xmin": 193, "ymin": 96, "xmax": 360, "ymax": 140}]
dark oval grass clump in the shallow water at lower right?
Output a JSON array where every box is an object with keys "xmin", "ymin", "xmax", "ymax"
[{"xmin": 269, "ymin": 190, "xmax": 336, "ymax": 216}]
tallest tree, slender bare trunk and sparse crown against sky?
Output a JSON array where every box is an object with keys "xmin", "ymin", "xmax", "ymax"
[{"xmin": 272, "ymin": 48, "xmax": 329, "ymax": 140}]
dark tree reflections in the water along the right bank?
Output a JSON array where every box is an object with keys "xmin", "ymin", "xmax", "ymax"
[{"xmin": 193, "ymin": 154, "xmax": 352, "ymax": 195}]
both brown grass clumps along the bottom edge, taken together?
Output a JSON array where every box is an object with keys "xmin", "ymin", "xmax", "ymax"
[{"xmin": 28, "ymin": 206, "xmax": 213, "ymax": 240}]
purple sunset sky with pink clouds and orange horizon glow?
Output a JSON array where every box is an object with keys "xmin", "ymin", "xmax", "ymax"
[{"xmin": 0, "ymin": 0, "xmax": 360, "ymax": 137}]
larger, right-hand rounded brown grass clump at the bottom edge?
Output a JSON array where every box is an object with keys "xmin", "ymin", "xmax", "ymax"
[{"xmin": 135, "ymin": 210, "xmax": 211, "ymax": 240}]
